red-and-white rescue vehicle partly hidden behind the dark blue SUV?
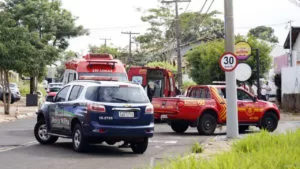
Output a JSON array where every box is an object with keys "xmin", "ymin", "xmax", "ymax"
[{"xmin": 63, "ymin": 54, "xmax": 128, "ymax": 84}]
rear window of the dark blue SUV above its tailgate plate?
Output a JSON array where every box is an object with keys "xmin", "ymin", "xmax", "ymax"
[{"xmin": 85, "ymin": 86, "xmax": 149, "ymax": 103}]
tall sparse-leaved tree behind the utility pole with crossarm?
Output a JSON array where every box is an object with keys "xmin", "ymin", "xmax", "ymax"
[{"xmin": 137, "ymin": 6, "xmax": 224, "ymax": 61}]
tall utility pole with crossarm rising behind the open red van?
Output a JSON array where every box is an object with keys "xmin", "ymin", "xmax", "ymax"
[{"xmin": 162, "ymin": 0, "xmax": 191, "ymax": 89}]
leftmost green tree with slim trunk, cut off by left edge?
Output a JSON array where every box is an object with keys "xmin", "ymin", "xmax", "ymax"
[{"xmin": 0, "ymin": 11, "xmax": 36, "ymax": 114}]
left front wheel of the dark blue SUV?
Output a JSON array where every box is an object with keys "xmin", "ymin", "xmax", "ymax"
[{"xmin": 34, "ymin": 120, "xmax": 58, "ymax": 144}]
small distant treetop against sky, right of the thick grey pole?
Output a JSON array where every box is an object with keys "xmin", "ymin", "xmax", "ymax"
[{"xmin": 248, "ymin": 26, "xmax": 278, "ymax": 43}]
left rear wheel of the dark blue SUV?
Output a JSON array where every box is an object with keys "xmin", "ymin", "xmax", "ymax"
[{"xmin": 72, "ymin": 124, "xmax": 87, "ymax": 152}]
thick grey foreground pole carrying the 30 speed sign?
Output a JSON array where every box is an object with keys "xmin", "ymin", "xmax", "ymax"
[{"xmin": 224, "ymin": 0, "xmax": 239, "ymax": 138}]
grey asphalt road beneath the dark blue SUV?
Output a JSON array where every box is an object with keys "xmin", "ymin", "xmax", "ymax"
[{"xmin": 0, "ymin": 118, "xmax": 300, "ymax": 169}]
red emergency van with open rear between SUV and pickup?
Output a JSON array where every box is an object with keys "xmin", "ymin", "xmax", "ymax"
[{"xmin": 128, "ymin": 66, "xmax": 176, "ymax": 98}]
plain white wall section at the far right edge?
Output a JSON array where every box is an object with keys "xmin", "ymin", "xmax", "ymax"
[{"xmin": 281, "ymin": 66, "xmax": 300, "ymax": 94}]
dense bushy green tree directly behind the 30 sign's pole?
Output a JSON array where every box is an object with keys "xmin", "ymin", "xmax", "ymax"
[{"xmin": 186, "ymin": 36, "xmax": 272, "ymax": 84}]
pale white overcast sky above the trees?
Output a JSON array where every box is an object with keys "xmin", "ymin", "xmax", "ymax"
[{"xmin": 62, "ymin": 0, "xmax": 300, "ymax": 54}]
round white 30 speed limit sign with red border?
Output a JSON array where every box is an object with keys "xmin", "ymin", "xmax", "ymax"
[{"xmin": 219, "ymin": 52, "xmax": 238, "ymax": 72}]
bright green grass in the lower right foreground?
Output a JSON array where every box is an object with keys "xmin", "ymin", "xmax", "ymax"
[{"xmin": 155, "ymin": 129, "xmax": 300, "ymax": 169}]
